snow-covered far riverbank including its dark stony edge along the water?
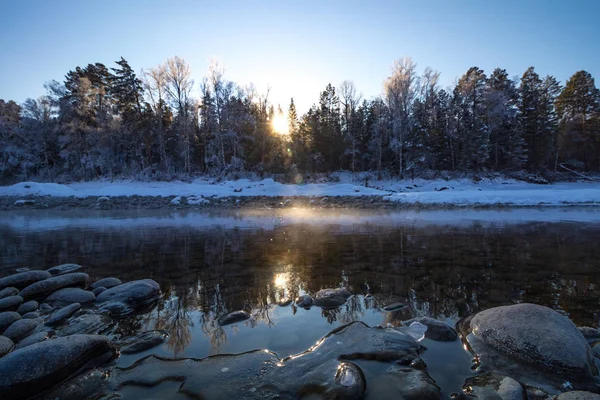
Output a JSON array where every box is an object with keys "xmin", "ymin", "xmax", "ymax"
[{"xmin": 0, "ymin": 179, "xmax": 600, "ymax": 209}]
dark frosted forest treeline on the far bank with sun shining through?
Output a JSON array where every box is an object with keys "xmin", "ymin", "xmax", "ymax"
[{"xmin": 0, "ymin": 57, "xmax": 600, "ymax": 181}]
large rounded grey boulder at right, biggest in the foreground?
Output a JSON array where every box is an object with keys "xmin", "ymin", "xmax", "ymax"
[{"xmin": 457, "ymin": 303, "xmax": 597, "ymax": 382}]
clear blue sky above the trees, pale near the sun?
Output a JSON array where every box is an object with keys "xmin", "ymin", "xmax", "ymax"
[{"xmin": 0, "ymin": 0, "xmax": 600, "ymax": 111}]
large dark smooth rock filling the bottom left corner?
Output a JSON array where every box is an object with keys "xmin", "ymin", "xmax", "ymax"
[{"xmin": 0, "ymin": 335, "xmax": 117, "ymax": 400}]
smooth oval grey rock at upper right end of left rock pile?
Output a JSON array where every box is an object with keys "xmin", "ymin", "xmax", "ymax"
[{"xmin": 96, "ymin": 279, "xmax": 161, "ymax": 316}]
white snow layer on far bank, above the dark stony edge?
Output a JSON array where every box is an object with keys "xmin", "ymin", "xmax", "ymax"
[{"xmin": 0, "ymin": 176, "xmax": 600, "ymax": 206}]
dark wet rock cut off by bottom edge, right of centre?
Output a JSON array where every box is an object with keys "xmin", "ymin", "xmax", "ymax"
[{"xmin": 369, "ymin": 366, "xmax": 440, "ymax": 400}]
